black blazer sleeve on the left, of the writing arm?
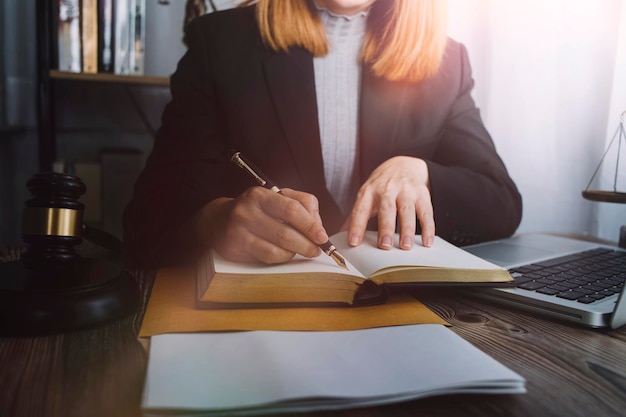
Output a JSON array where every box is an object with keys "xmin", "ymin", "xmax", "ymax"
[{"xmin": 124, "ymin": 18, "xmax": 236, "ymax": 267}]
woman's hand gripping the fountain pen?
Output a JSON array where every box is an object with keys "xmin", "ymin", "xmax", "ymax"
[{"xmin": 193, "ymin": 186, "xmax": 328, "ymax": 264}]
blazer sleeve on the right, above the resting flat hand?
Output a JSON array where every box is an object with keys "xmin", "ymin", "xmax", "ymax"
[{"xmin": 427, "ymin": 44, "xmax": 522, "ymax": 245}]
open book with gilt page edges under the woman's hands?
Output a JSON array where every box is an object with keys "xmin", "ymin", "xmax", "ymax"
[{"xmin": 196, "ymin": 231, "xmax": 513, "ymax": 308}]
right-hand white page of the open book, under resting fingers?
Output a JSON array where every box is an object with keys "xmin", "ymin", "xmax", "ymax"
[{"xmin": 331, "ymin": 230, "xmax": 502, "ymax": 277}]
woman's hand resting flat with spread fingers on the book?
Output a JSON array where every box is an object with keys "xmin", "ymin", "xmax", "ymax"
[{"xmin": 348, "ymin": 156, "xmax": 435, "ymax": 249}]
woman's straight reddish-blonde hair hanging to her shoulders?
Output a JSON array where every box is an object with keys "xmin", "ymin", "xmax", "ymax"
[{"xmin": 246, "ymin": 0, "xmax": 447, "ymax": 81}]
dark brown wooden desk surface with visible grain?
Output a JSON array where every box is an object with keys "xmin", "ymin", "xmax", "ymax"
[{"xmin": 0, "ymin": 272, "xmax": 626, "ymax": 417}]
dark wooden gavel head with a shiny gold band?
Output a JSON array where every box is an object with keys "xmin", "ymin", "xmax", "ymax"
[{"xmin": 22, "ymin": 172, "xmax": 86, "ymax": 271}]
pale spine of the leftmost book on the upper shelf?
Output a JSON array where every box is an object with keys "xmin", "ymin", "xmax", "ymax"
[{"xmin": 58, "ymin": 0, "xmax": 82, "ymax": 72}]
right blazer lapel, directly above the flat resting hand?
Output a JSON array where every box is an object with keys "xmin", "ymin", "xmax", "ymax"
[{"xmin": 359, "ymin": 67, "xmax": 408, "ymax": 179}]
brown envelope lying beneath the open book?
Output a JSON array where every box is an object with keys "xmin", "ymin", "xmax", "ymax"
[{"xmin": 139, "ymin": 269, "xmax": 447, "ymax": 337}]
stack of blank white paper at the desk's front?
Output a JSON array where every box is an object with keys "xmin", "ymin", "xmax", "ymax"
[{"xmin": 142, "ymin": 324, "xmax": 525, "ymax": 416}]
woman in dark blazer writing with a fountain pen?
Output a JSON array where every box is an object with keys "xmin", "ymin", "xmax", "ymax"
[{"xmin": 124, "ymin": 0, "xmax": 522, "ymax": 266}]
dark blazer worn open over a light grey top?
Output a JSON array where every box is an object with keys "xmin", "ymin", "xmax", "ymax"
[{"xmin": 124, "ymin": 6, "xmax": 522, "ymax": 266}]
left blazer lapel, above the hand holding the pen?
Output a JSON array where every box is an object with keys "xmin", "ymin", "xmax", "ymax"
[{"xmin": 264, "ymin": 48, "xmax": 326, "ymax": 195}]
